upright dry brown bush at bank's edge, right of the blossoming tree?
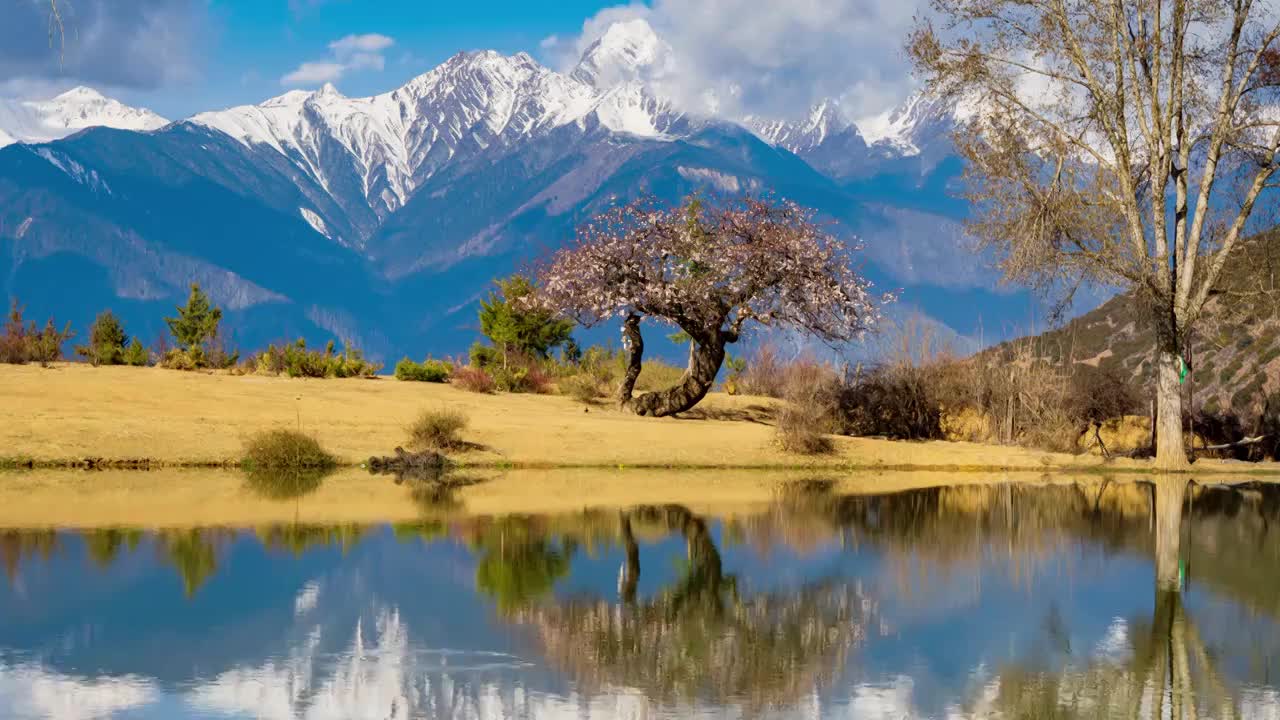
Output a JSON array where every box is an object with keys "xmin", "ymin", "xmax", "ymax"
[{"xmin": 777, "ymin": 360, "xmax": 844, "ymax": 455}]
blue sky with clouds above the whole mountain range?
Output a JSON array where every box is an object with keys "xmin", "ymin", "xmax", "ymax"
[{"xmin": 0, "ymin": 0, "xmax": 923, "ymax": 120}]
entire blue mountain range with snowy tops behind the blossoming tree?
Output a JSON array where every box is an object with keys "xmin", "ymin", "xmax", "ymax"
[{"xmin": 0, "ymin": 20, "xmax": 1028, "ymax": 357}]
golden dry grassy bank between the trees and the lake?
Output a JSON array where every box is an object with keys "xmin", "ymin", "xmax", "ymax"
[{"xmin": 0, "ymin": 364, "xmax": 1276, "ymax": 473}]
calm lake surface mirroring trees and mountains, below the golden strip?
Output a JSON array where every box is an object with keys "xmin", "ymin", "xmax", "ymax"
[{"xmin": 0, "ymin": 479, "xmax": 1280, "ymax": 720}]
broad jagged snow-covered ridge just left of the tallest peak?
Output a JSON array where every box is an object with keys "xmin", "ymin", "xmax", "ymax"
[{"xmin": 189, "ymin": 51, "xmax": 682, "ymax": 246}]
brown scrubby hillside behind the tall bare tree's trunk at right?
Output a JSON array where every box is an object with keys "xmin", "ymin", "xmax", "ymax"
[{"xmin": 992, "ymin": 229, "xmax": 1280, "ymax": 420}]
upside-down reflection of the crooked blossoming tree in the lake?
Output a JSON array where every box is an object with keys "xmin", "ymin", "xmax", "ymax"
[{"xmin": 515, "ymin": 506, "xmax": 872, "ymax": 708}]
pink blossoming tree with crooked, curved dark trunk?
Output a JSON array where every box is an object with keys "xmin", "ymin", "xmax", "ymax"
[{"xmin": 536, "ymin": 199, "xmax": 879, "ymax": 416}]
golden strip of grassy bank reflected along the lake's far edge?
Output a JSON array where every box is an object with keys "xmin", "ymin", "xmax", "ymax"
[{"xmin": 0, "ymin": 470, "xmax": 1257, "ymax": 529}]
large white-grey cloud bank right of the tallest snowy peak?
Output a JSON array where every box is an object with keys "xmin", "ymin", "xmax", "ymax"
[{"xmin": 544, "ymin": 0, "xmax": 927, "ymax": 118}]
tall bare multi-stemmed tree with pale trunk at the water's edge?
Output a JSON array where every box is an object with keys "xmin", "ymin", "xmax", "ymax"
[{"xmin": 908, "ymin": 0, "xmax": 1280, "ymax": 469}]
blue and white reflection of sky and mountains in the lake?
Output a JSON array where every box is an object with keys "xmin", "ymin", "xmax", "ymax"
[{"xmin": 0, "ymin": 481, "xmax": 1280, "ymax": 720}]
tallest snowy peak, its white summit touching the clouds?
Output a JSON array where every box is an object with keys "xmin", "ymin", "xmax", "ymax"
[{"xmin": 570, "ymin": 18, "xmax": 672, "ymax": 88}]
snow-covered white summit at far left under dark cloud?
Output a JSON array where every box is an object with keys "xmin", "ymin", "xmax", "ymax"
[{"xmin": 0, "ymin": 87, "xmax": 169, "ymax": 147}]
